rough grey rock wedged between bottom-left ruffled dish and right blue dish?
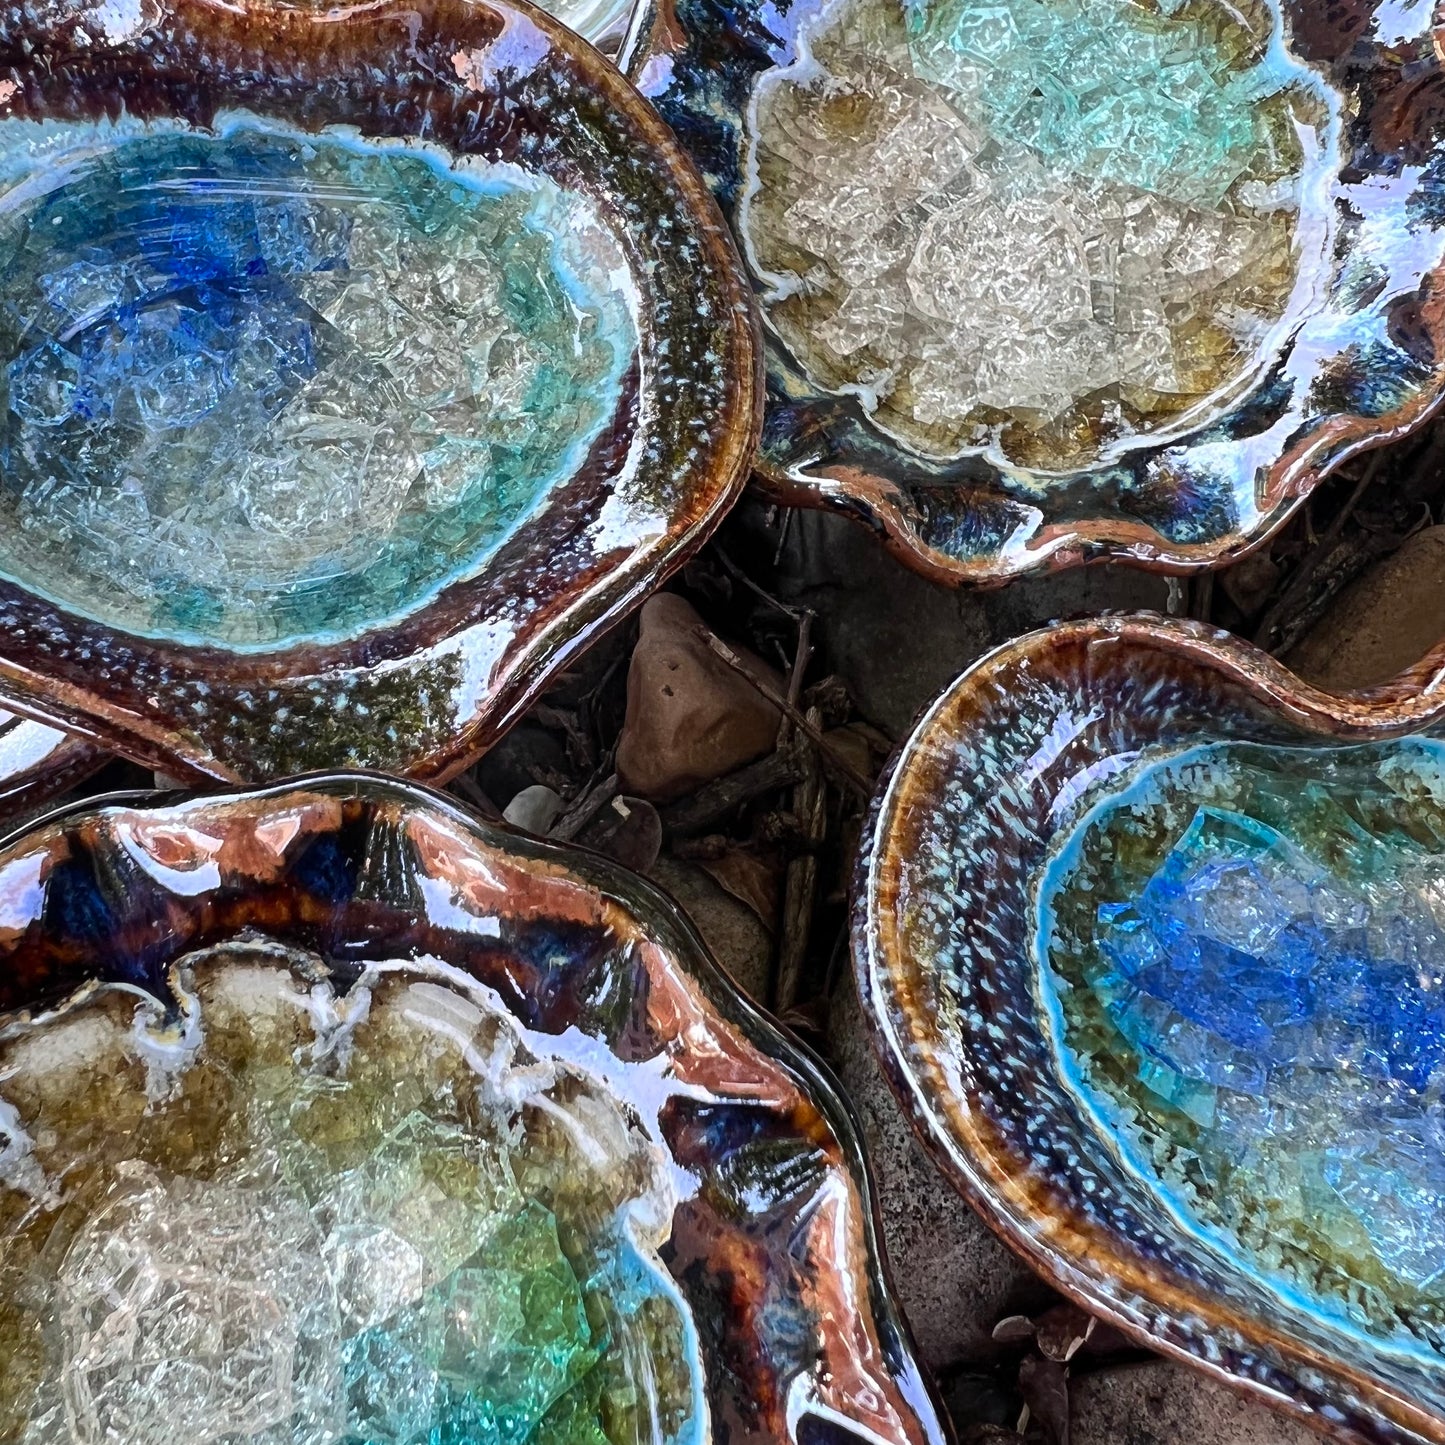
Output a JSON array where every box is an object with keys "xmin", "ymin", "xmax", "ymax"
[{"xmin": 828, "ymin": 981, "xmax": 1058, "ymax": 1371}]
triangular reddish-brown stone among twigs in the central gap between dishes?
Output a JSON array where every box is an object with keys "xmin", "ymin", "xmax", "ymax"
[{"xmin": 617, "ymin": 592, "xmax": 785, "ymax": 802}]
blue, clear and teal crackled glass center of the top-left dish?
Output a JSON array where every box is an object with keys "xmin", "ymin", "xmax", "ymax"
[{"xmin": 0, "ymin": 118, "xmax": 637, "ymax": 647}]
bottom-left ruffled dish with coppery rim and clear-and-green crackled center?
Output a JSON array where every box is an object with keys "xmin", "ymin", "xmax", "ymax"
[{"xmin": 0, "ymin": 775, "xmax": 945, "ymax": 1445}]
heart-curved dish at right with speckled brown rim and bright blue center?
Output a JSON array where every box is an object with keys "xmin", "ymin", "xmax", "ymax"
[{"xmin": 854, "ymin": 617, "xmax": 1445, "ymax": 1442}]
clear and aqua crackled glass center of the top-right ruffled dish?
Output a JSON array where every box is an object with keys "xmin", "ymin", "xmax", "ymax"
[{"xmin": 741, "ymin": 0, "xmax": 1324, "ymax": 470}]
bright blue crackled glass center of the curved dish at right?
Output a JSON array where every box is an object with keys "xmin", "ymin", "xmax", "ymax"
[{"xmin": 1042, "ymin": 740, "xmax": 1445, "ymax": 1351}]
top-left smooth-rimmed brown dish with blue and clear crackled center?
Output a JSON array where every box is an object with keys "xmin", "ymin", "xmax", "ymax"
[{"xmin": 0, "ymin": 0, "xmax": 759, "ymax": 780}]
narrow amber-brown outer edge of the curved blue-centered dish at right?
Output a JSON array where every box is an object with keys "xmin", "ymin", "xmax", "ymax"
[{"xmin": 853, "ymin": 614, "xmax": 1445, "ymax": 1445}]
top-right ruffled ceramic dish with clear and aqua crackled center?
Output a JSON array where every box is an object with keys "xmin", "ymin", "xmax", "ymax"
[{"xmin": 623, "ymin": 0, "xmax": 1445, "ymax": 582}]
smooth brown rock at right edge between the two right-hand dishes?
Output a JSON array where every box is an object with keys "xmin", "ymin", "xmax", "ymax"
[{"xmin": 1285, "ymin": 526, "xmax": 1445, "ymax": 692}]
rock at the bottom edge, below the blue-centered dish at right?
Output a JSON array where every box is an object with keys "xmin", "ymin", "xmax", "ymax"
[{"xmin": 1069, "ymin": 1360, "xmax": 1319, "ymax": 1445}]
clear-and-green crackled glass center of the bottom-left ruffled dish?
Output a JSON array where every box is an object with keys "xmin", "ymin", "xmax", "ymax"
[{"xmin": 0, "ymin": 946, "xmax": 705, "ymax": 1445}]
